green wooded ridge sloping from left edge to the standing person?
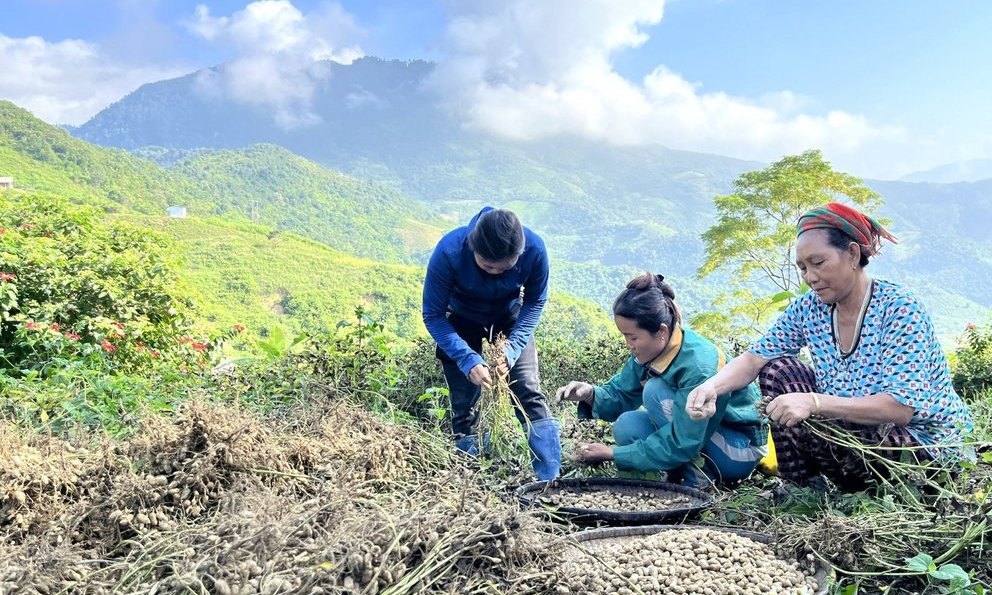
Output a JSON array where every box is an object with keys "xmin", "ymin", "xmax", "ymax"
[{"xmin": 0, "ymin": 101, "xmax": 447, "ymax": 262}]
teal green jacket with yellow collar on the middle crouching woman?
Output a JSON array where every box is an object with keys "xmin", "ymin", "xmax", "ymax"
[{"xmin": 579, "ymin": 326, "xmax": 768, "ymax": 471}]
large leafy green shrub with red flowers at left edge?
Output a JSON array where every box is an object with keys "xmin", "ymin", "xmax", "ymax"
[{"xmin": 0, "ymin": 196, "xmax": 208, "ymax": 377}]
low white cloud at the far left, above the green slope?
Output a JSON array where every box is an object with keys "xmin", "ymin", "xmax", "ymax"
[{"xmin": 0, "ymin": 34, "xmax": 184, "ymax": 124}]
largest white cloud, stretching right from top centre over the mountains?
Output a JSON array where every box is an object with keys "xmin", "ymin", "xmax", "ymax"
[{"xmin": 433, "ymin": 0, "xmax": 906, "ymax": 177}]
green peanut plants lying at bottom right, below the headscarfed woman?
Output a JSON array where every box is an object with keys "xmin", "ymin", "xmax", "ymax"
[{"xmin": 705, "ymin": 412, "xmax": 992, "ymax": 594}]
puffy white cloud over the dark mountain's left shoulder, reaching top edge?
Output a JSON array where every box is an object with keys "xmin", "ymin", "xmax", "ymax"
[{"xmin": 187, "ymin": 0, "xmax": 363, "ymax": 129}]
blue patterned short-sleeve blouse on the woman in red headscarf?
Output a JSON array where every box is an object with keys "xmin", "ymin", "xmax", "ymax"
[{"xmin": 751, "ymin": 279, "xmax": 973, "ymax": 458}]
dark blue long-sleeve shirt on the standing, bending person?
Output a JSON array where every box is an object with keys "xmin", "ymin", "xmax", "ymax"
[{"xmin": 423, "ymin": 207, "xmax": 549, "ymax": 376}]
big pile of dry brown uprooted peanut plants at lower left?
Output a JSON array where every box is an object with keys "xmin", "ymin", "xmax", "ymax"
[{"xmin": 0, "ymin": 402, "xmax": 556, "ymax": 595}]
